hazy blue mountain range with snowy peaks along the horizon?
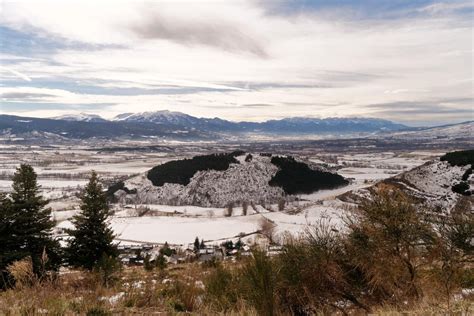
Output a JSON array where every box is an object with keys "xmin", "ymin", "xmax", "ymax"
[{"xmin": 0, "ymin": 111, "xmax": 472, "ymax": 140}]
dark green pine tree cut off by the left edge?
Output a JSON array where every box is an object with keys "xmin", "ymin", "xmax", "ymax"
[{"xmin": 0, "ymin": 164, "xmax": 61, "ymax": 286}]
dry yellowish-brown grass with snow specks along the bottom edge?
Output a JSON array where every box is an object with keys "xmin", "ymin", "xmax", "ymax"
[{"xmin": 0, "ymin": 261, "xmax": 474, "ymax": 315}]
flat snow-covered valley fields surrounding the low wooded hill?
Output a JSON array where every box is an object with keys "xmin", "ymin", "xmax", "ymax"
[{"xmin": 0, "ymin": 147, "xmax": 448, "ymax": 244}]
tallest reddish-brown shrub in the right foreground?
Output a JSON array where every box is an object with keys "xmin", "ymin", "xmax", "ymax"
[{"xmin": 346, "ymin": 189, "xmax": 435, "ymax": 304}]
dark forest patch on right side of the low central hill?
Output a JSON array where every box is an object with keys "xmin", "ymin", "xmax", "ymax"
[{"xmin": 269, "ymin": 156, "xmax": 348, "ymax": 194}]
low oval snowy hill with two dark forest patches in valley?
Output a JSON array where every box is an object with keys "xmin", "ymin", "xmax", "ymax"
[{"xmin": 109, "ymin": 152, "xmax": 348, "ymax": 207}]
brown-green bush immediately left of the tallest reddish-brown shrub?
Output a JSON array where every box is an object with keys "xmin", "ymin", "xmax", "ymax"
[{"xmin": 277, "ymin": 222, "xmax": 369, "ymax": 315}]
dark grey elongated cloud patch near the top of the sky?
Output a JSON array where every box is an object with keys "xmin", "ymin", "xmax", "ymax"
[{"xmin": 129, "ymin": 12, "xmax": 268, "ymax": 58}]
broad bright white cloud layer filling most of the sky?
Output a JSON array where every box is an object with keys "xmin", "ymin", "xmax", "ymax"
[{"xmin": 0, "ymin": 0, "xmax": 473, "ymax": 126}]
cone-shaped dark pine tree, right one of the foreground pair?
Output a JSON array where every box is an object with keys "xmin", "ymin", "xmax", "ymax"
[{"xmin": 67, "ymin": 171, "xmax": 118, "ymax": 270}]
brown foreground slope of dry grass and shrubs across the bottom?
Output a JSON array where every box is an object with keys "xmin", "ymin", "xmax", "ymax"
[{"xmin": 0, "ymin": 190, "xmax": 474, "ymax": 315}]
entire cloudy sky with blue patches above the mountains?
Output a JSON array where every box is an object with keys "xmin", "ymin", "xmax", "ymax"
[{"xmin": 0, "ymin": 0, "xmax": 474, "ymax": 126}]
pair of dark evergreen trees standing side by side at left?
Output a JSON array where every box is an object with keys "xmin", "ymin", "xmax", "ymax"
[{"xmin": 0, "ymin": 164, "xmax": 118, "ymax": 288}]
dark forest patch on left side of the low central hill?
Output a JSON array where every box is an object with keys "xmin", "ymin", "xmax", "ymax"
[{"xmin": 147, "ymin": 151, "xmax": 243, "ymax": 186}]
